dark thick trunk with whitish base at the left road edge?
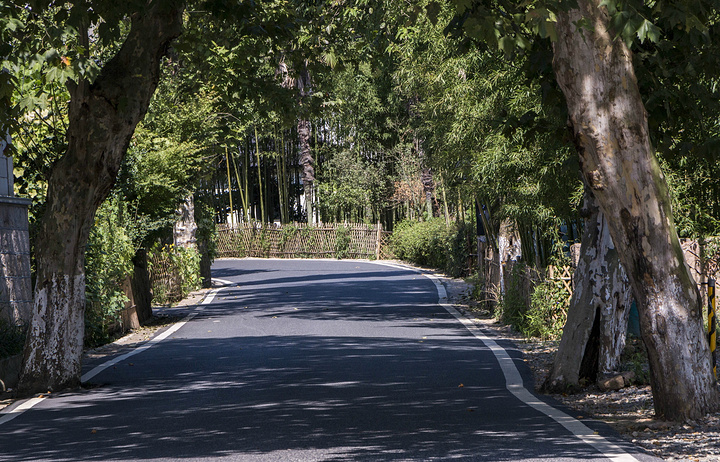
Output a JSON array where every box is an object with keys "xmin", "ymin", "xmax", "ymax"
[{"xmin": 20, "ymin": 2, "xmax": 183, "ymax": 394}]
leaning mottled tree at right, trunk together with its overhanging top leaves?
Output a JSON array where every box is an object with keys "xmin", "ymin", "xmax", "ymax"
[{"xmin": 456, "ymin": 0, "xmax": 718, "ymax": 420}]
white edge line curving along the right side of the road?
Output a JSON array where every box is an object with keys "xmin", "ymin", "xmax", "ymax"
[{"xmin": 378, "ymin": 262, "xmax": 639, "ymax": 462}]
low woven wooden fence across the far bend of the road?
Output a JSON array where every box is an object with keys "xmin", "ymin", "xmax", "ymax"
[{"xmin": 217, "ymin": 223, "xmax": 390, "ymax": 259}]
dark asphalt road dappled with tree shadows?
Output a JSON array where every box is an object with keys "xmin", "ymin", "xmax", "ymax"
[{"xmin": 0, "ymin": 260, "xmax": 659, "ymax": 462}]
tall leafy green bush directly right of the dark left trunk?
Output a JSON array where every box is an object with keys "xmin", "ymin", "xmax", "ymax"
[{"xmin": 85, "ymin": 199, "xmax": 135, "ymax": 347}]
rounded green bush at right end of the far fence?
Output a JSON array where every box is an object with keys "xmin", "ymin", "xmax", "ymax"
[{"xmin": 390, "ymin": 218, "xmax": 472, "ymax": 277}]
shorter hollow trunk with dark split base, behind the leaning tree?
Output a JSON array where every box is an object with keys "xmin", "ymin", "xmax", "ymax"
[{"xmin": 543, "ymin": 191, "xmax": 632, "ymax": 393}]
